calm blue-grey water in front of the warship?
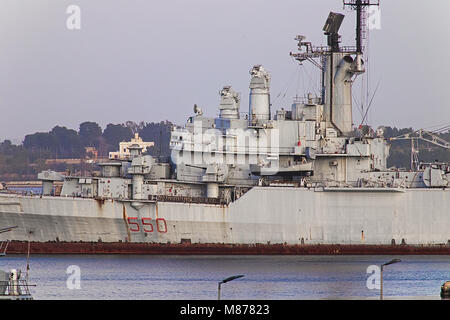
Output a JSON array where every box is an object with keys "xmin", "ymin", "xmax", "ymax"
[{"xmin": 0, "ymin": 255, "xmax": 450, "ymax": 300}]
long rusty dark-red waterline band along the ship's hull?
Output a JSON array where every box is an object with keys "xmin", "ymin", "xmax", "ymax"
[{"xmin": 8, "ymin": 241, "xmax": 450, "ymax": 255}]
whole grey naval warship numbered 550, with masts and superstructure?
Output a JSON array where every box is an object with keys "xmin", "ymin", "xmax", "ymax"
[{"xmin": 0, "ymin": 0, "xmax": 450, "ymax": 254}]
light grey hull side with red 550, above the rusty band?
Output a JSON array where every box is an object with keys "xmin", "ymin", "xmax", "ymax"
[{"xmin": 0, "ymin": 187, "xmax": 450, "ymax": 253}]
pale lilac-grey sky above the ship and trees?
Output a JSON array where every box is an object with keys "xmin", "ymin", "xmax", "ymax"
[{"xmin": 0, "ymin": 0, "xmax": 450, "ymax": 143}]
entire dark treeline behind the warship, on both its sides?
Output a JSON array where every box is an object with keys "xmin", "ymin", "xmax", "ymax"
[{"xmin": 0, "ymin": 121, "xmax": 450, "ymax": 181}]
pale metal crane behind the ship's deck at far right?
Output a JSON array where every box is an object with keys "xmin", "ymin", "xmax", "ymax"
[{"xmin": 389, "ymin": 129, "xmax": 450, "ymax": 170}]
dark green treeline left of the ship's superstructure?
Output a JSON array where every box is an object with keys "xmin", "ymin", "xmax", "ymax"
[{"xmin": 0, "ymin": 121, "xmax": 172, "ymax": 181}]
